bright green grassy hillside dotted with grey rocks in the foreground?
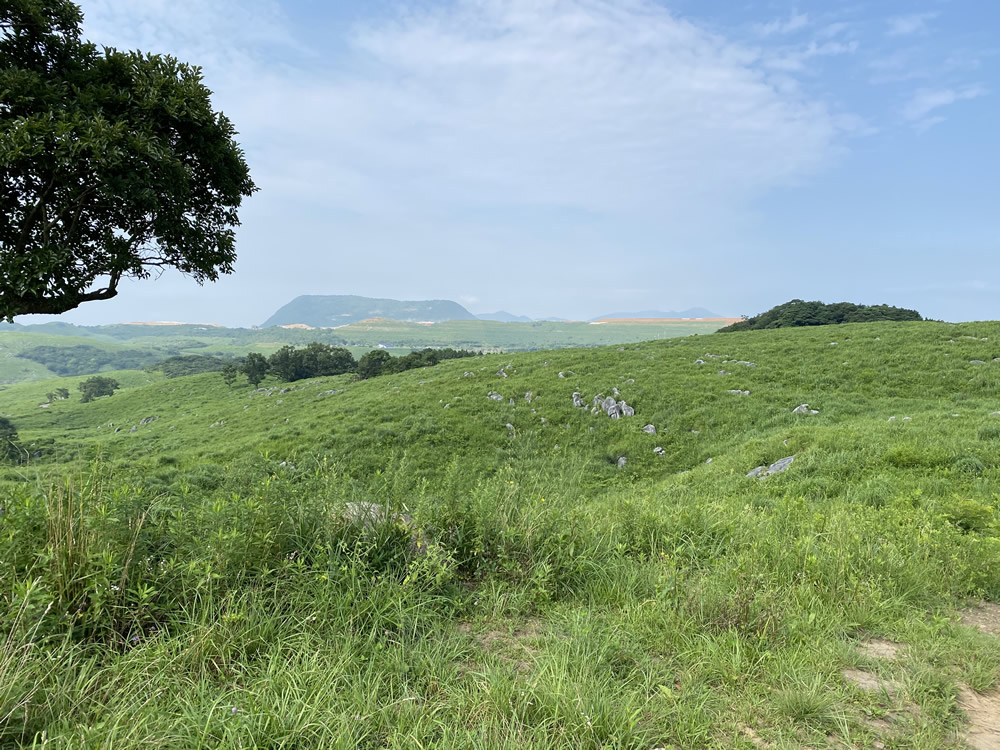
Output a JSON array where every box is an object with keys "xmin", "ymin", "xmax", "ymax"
[{"xmin": 0, "ymin": 323, "xmax": 1000, "ymax": 750}]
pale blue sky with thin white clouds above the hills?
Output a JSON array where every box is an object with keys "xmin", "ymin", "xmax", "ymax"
[{"xmin": 18, "ymin": 0, "xmax": 1000, "ymax": 326}]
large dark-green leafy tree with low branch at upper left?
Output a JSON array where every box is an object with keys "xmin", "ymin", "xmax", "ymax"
[{"xmin": 0, "ymin": 0, "xmax": 257, "ymax": 320}]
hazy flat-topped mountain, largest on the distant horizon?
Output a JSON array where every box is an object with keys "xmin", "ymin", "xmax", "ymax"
[{"xmin": 261, "ymin": 294, "xmax": 476, "ymax": 328}]
